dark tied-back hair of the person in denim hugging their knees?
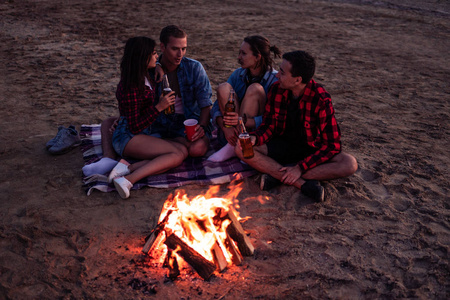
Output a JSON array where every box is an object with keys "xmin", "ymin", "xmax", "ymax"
[{"xmin": 244, "ymin": 35, "xmax": 281, "ymax": 74}]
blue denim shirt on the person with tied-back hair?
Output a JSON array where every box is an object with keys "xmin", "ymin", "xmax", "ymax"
[{"xmin": 211, "ymin": 68, "xmax": 278, "ymax": 127}]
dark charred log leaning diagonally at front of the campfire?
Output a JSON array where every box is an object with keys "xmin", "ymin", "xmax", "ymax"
[{"xmin": 164, "ymin": 232, "xmax": 216, "ymax": 280}]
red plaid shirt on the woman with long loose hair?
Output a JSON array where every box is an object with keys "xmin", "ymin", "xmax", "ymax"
[{"xmin": 116, "ymin": 80, "xmax": 159, "ymax": 134}]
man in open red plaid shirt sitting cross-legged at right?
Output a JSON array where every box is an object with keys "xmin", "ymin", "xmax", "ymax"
[{"xmin": 236, "ymin": 51, "xmax": 358, "ymax": 202}]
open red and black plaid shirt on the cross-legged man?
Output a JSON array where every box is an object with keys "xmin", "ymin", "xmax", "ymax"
[{"xmin": 251, "ymin": 80, "xmax": 341, "ymax": 173}]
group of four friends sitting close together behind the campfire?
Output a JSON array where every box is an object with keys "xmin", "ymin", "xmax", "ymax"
[{"xmin": 83, "ymin": 25, "xmax": 358, "ymax": 201}]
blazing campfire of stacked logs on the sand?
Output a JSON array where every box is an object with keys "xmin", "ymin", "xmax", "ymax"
[{"xmin": 142, "ymin": 186, "xmax": 254, "ymax": 280}]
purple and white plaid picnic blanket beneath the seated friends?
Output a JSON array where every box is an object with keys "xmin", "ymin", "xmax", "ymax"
[{"xmin": 80, "ymin": 124, "xmax": 256, "ymax": 195}]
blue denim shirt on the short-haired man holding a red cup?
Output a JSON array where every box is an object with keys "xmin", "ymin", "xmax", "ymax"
[{"xmin": 155, "ymin": 57, "xmax": 212, "ymax": 120}]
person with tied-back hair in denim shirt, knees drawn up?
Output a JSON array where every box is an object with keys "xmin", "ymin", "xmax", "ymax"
[{"xmin": 208, "ymin": 35, "xmax": 281, "ymax": 162}]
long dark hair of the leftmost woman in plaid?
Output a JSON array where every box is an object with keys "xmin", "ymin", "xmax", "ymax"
[{"xmin": 120, "ymin": 36, "xmax": 156, "ymax": 92}]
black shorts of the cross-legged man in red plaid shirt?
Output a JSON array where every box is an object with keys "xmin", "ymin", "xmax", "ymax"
[{"xmin": 266, "ymin": 138, "xmax": 316, "ymax": 165}]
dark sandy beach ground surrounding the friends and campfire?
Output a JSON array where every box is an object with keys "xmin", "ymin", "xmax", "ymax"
[{"xmin": 0, "ymin": 0, "xmax": 450, "ymax": 299}]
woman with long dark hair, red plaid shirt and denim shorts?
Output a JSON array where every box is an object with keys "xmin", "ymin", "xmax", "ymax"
[{"xmin": 108, "ymin": 37, "xmax": 188, "ymax": 199}]
